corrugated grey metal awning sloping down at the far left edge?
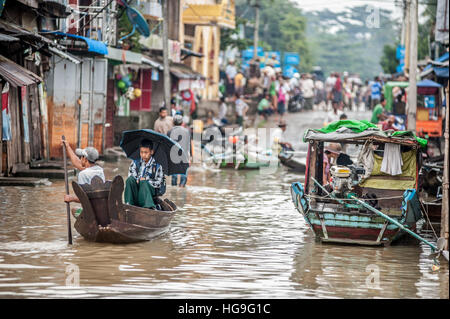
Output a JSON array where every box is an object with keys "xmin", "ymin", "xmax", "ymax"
[{"xmin": 0, "ymin": 55, "xmax": 42, "ymax": 87}]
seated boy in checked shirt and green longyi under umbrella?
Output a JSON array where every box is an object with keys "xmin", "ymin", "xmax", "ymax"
[{"xmin": 124, "ymin": 139, "xmax": 165, "ymax": 208}]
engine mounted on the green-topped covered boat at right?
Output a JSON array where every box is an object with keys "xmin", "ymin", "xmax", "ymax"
[{"xmin": 330, "ymin": 165, "xmax": 365, "ymax": 198}]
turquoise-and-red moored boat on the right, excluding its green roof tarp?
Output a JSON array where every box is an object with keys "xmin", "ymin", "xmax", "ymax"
[{"xmin": 291, "ymin": 130, "xmax": 422, "ymax": 245}]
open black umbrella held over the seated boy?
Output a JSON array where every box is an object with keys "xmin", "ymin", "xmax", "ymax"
[{"xmin": 120, "ymin": 129, "xmax": 189, "ymax": 175}]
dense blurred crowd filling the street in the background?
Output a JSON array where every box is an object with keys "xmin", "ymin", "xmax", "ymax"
[{"xmin": 218, "ymin": 56, "xmax": 392, "ymax": 125}]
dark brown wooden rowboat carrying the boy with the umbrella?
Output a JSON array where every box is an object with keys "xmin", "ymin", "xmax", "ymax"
[{"xmin": 72, "ymin": 175, "xmax": 177, "ymax": 244}]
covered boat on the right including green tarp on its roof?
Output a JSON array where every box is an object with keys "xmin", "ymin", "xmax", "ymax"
[{"xmin": 291, "ymin": 120, "xmax": 426, "ymax": 245}]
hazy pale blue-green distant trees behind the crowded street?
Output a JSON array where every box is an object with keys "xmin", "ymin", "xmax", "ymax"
[{"xmin": 307, "ymin": 6, "xmax": 400, "ymax": 79}]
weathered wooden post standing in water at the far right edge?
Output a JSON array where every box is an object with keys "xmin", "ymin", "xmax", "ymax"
[{"xmin": 441, "ymin": 84, "xmax": 450, "ymax": 250}]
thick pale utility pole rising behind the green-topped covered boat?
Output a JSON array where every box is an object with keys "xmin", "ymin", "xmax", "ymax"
[{"xmin": 407, "ymin": 0, "xmax": 419, "ymax": 132}]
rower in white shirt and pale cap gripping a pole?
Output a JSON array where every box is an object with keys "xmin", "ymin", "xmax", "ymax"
[{"xmin": 61, "ymin": 140, "xmax": 105, "ymax": 217}]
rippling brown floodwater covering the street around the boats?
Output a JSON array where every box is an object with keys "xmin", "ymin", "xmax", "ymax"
[{"xmin": 0, "ymin": 156, "xmax": 449, "ymax": 298}]
